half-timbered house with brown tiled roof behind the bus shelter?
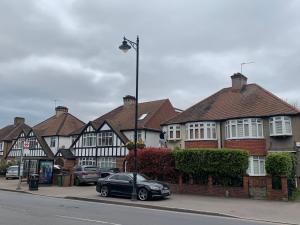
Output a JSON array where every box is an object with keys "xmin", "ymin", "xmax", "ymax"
[{"xmin": 5, "ymin": 106, "xmax": 84, "ymax": 179}]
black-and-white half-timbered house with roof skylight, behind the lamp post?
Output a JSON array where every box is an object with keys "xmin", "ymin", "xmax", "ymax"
[{"xmin": 70, "ymin": 95, "xmax": 177, "ymax": 169}]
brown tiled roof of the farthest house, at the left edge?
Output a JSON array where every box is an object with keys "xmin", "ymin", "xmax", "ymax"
[{"xmin": 0, "ymin": 123, "xmax": 31, "ymax": 141}]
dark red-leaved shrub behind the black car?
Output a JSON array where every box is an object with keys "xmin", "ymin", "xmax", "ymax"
[{"xmin": 126, "ymin": 148, "xmax": 176, "ymax": 181}]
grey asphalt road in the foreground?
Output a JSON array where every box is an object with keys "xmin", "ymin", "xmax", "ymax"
[{"xmin": 0, "ymin": 191, "xmax": 276, "ymax": 225}]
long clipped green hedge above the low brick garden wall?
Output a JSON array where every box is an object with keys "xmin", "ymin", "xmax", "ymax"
[{"xmin": 172, "ymin": 148, "xmax": 249, "ymax": 177}]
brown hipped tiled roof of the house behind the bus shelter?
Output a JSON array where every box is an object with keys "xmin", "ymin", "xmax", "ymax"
[{"xmin": 33, "ymin": 113, "xmax": 84, "ymax": 137}]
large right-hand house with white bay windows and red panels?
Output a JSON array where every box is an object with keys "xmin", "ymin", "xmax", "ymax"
[{"xmin": 162, "ymin": 73, "xmax": 300, "ymax": 177}]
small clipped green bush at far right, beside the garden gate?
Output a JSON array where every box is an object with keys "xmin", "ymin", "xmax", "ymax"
[{"xmin": 266, "ymin": 152, "xmax": 295, "ymax": 177}]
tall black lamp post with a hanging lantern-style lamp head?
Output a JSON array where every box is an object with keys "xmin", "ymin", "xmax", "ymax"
[{"xmin": 119, "ymin": 36, "xmax": 139, "ymax": 201}]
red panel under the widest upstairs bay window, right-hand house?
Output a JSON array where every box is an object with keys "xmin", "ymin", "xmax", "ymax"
[{"xmin": 224, "ymin": 139, "xmax": 267, "ymax": 156}]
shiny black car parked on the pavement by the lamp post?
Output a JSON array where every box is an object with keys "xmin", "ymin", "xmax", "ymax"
[{"xmin": 96, "ymin": 173, "xmax": 171, "ymax": 201}]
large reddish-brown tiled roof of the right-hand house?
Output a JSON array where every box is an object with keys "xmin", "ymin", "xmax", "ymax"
[{"xmin": 164, "ymin": 84, "xmax": 300, "ymax": 124}]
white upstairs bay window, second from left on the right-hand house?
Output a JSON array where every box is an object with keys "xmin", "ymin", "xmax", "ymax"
[{"xmin": 186, "ymin": 122, "xmax": 217, "ymax": 141}]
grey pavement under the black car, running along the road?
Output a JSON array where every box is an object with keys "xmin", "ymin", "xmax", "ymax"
[{"xmin": 0, "ymin": 178, "xmax": 300, "ymax": 225}]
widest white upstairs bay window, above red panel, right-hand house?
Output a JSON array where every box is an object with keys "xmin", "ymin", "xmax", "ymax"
[{"xmin": 225, "ymin": 118, "xmax": 264, "ymax": 140}]
